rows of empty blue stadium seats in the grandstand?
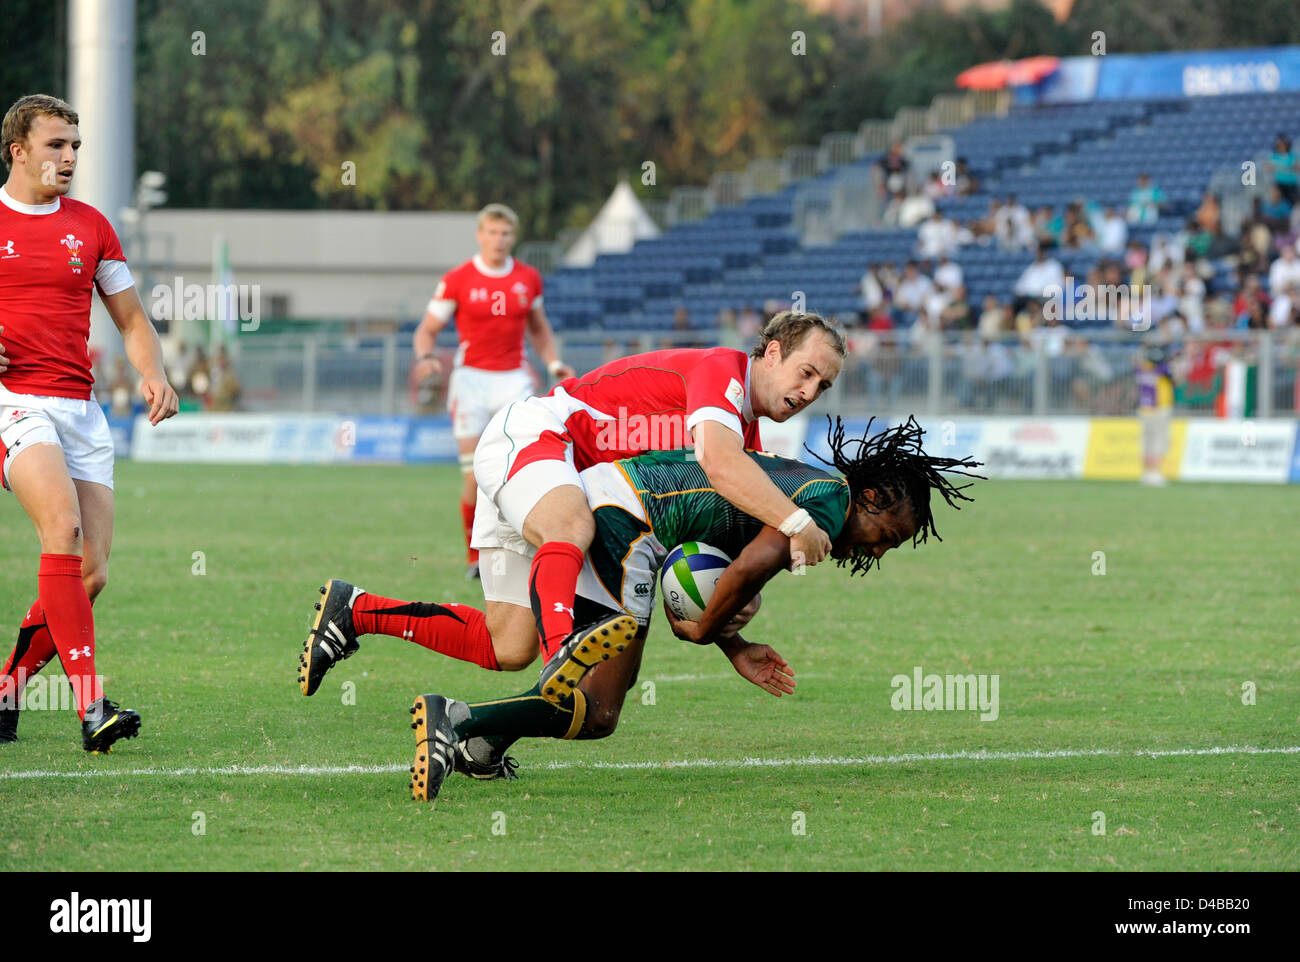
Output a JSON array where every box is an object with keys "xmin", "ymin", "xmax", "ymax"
[{"xmin": 546, "ymin": 94, "xmax": 1300, "ymax": 330}]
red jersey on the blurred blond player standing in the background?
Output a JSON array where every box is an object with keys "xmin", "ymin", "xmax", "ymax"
[{"xmin": 433, "ymin": 255, "xmax": 542, "ymax": 371}]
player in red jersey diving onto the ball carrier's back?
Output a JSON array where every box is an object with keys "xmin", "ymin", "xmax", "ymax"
[{"xmin": 299, "ymin": 312, "xmax": 845, "ymax": 701}]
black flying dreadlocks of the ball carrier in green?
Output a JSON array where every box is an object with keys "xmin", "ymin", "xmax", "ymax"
[{"xmin": 803, "ymin": 415, "xmax": 987, "ymax": 575}]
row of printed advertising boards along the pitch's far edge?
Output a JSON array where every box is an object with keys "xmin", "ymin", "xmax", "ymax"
[{"xmin": 122, "ymin": 413, "xmax": 1300, "ymax": 484}]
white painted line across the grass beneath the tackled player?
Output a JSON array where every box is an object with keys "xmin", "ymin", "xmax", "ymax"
[{"xmin": 0, "ymin": 745, "xmax": 1300, "ymax": 781}]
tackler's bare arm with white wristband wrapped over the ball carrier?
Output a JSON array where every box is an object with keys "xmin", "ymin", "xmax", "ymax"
[{"xmin": 694, "ymin": 421, "xmax": 831, "ymax": 566}]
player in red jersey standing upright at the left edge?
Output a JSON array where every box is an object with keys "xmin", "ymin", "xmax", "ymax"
[{"xmin": 0, "ymin": 94, "xmax": 178, "ymax": 753}]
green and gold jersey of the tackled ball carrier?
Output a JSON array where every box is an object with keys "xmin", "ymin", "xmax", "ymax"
[{"xmin": 618, "ymin": 450, "xmax": 849, "ymax": 558}]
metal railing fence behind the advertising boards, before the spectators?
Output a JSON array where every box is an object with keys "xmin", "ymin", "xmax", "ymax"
[{"xmin": 218, "ymin": 330, "xmax": 1300, "ymax": 417}]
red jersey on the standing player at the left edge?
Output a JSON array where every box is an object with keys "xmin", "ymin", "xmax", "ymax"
[{"xmin": 0, "ymin": 194, "xmax": 126, "ymax": 400}]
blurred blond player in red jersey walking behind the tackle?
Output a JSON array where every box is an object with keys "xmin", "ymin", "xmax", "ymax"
[{"xmin": 415, "ymin": 204, "xmax": 573, "ymax": 577}]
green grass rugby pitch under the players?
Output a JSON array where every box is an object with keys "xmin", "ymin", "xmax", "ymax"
[{"xmin": 0, "ymin": 462, "xmax": 1300, "ymax": 871}]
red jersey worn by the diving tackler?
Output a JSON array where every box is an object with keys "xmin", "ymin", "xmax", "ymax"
[{"xmin": 551, "ymin": 347, "xmax": 763, "ymax": 471}]
